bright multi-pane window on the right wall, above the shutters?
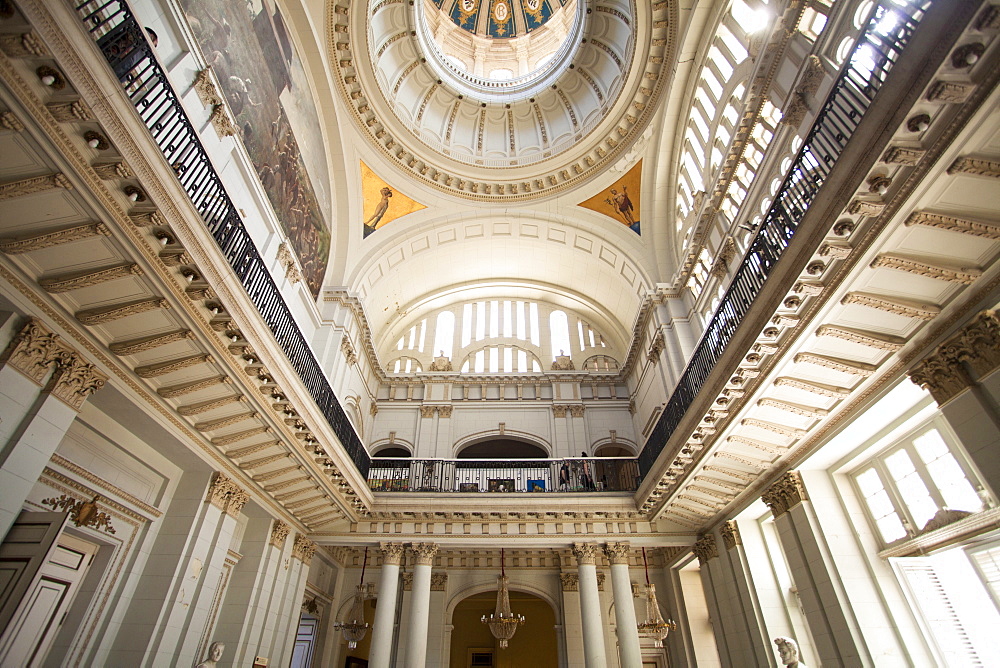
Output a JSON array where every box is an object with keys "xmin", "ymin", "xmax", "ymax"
[{"xmin": 853, "ymin": 424, "xmax": 983, "ymax": 543}]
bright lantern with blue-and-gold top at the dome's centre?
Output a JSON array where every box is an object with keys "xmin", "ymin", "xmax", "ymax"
[{"xmin": 415, "ymin": 0, "xmax": 585, "ymax": 101}]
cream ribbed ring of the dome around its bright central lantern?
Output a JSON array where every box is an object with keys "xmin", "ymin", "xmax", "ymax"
[{"xmin": 328, "ymin": 0, "xmax": 679, "ymax": 201}]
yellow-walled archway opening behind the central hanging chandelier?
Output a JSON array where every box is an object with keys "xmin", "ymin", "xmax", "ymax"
[{"xmin": 448, "ymin": 585, "xmax": 559, "ymax": 668}]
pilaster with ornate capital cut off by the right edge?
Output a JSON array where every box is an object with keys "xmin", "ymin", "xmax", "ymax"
[{"xmin": 910, "ymin": 310, "xmax": 1000, "ymax": 499}]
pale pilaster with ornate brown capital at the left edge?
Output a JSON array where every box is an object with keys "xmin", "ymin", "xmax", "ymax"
[{"xmin": 0, "ymin": 318, "xmax": 107, "ymax": 537}]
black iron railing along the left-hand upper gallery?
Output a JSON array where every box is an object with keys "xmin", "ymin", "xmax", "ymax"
[{"xmin": 76, "ymin": 0, "xmax": 371, "ymax": 476}]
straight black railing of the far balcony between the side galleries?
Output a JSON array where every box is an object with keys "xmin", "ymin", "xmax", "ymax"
[{"xmin": 368, "ymin": 457, "xmax": 639, "ymax": 493}]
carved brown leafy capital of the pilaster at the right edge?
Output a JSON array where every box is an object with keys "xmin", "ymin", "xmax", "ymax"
[{"xmin": 909, "ymin": 311, "xmax": 1000, "ymax": 405}]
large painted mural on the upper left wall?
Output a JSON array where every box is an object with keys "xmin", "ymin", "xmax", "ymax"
[{"xmin": 181, "ymin": 0, "xmax": 332, "ymax": 297}]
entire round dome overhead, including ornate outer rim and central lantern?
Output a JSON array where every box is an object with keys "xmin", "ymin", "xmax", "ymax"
[{"xmin": 328, "ymin": 0, "xmax": 678, "ymax": 202}]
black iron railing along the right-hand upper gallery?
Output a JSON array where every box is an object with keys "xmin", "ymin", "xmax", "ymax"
[{"xmin": 639, "ymin": 0, "xmax": 930, "ymax": 477}]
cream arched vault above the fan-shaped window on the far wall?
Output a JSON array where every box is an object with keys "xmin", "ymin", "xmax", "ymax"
[{"xmin": 347, "ymin": 211, "xmax": 653, "ymax": 351}]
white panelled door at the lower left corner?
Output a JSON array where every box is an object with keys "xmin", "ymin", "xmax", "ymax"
[{"xmin": 0, "ymin": 533, "xmax": 98, "ymax": 668}]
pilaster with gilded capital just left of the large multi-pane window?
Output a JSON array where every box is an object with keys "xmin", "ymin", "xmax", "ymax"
[{"xmin": 761, "ymin": 471, "xmax": 874, "ymax": 666}]
